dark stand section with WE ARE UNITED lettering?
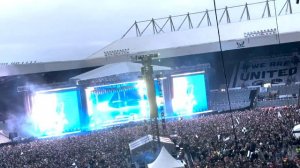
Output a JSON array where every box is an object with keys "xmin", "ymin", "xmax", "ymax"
[{"xmin": 231, "ymin": 56, "xmax": 300, "ymax": 87}]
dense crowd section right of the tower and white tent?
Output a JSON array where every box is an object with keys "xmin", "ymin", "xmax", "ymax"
[{"xmin": 168, "ymin": 107, "xmax": 300, "ymax": 168}]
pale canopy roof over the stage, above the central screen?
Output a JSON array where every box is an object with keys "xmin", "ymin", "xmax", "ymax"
[{"xmin": 71, "ymin": 62, "xmax": 171, "ymax": 80}]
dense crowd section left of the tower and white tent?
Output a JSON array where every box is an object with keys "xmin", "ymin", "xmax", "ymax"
[{"xmin": 0, "ymin": 127, "xmax": 144, "ymax": 168}]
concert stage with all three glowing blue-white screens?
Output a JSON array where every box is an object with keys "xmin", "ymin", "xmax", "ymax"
[{"xmin": 21, "ymin": 62, "xmax": 209, "ymax": 137}]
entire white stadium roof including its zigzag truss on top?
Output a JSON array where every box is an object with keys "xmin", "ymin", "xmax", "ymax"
[{"xmin": 0, "ymin": 0, "xmax": 300, "ymax": 77}]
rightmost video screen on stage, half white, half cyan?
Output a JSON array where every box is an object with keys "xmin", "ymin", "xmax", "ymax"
[{"xmin": 172, "ymin": 74, "xmax": 207, "ymax": 116}]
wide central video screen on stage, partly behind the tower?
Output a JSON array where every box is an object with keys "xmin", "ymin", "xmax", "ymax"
[{"xmin": 85, "ymin": 80, "xmax": 162, "ymax": 130}]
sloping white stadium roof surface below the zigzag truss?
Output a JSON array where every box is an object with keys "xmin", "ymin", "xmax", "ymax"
[{"xmin": 88, "ymin": 14, "xmax": 300, "ymax": 59}]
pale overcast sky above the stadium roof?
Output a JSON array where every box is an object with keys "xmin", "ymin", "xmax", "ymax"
[{"xmin": 0, "ymin": 0, "xmax": 298, "ymax": 63}]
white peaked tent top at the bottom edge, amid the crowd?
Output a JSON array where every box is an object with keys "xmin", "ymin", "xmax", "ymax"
[{"xmin": 148, "ymin": 147, "xmax": 184, "ymax": 168}]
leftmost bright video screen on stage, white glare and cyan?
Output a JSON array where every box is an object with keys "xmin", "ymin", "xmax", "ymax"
[{"xmin": 31, "ymin": 89, "xmax": 80, "ymax": 136}]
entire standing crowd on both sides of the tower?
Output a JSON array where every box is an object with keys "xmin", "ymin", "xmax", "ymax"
[{"xmin": 0, "ymin": 107, "xmax": 300, "ymax": 168}]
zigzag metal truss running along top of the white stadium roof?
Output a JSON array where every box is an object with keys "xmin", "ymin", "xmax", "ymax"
[{"xmin": 122, "ymin": 0, "xmax": 293, "ymax": 38}]
